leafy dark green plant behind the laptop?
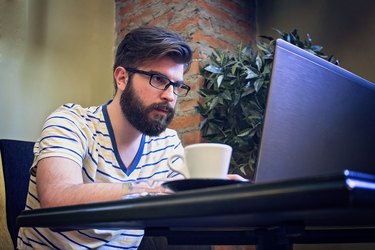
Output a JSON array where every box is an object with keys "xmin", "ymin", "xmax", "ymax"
[{"xmin": 196, "ymin": 30, "xmax": 338, "ymax": 178}]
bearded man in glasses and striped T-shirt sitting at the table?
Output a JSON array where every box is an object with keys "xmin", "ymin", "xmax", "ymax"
[{"xmin": 18, "ymin": 27, "xmax": 192, "ymax": 249}]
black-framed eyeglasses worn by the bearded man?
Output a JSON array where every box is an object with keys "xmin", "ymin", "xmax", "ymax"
[{"xmin": 125, "ymin": 67, "xmax": 190, "ymax": 96}]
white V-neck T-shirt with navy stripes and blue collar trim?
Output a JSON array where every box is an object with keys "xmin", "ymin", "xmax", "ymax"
[{"xmin": 17, "ymin": 104, "xmax": 183, "ymax": 249}]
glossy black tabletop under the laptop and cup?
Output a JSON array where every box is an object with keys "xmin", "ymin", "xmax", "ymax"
[{"xmin": 17, "ymin": 171, "xmax": 375, "ymax": 246}]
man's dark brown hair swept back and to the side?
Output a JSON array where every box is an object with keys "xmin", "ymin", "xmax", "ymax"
[{"xmin": 113, "ymin": 26, "xmax": 192, "ymax": 92}]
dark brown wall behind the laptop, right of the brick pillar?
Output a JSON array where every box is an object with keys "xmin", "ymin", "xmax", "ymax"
[{"xmin": 257, "ymin": 0, "xmax": 375, "ymax": 82}]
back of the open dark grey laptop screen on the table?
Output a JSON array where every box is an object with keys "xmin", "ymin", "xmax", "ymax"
[{"xmin": 255, "ymin": 39, "xmax": 375, "ymax": 183}]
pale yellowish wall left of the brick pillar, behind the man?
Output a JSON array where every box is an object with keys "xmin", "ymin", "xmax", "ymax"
[{"xmin": 0, "ymin": 0, "xmax": 115, "ymax": 140}]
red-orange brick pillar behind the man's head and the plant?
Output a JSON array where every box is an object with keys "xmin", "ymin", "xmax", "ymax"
[{"xmin": 115, "ymin": 0, "xmax": 256, "ymax": 146}]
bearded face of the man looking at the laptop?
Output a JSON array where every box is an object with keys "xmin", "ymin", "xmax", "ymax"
[{"xmin": 120, "ymin": 59, "xmax": 183, "ymax": 136}]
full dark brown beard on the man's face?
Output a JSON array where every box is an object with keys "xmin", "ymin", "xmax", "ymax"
[{"xmin": 120, "ymin": 78, "xmax": 174, "ymax": 136}]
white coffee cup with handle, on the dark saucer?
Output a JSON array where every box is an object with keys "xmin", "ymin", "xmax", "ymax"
[{"xmin": 168, "ymin": 143, "xmax": 232, "ymax": 179}]
